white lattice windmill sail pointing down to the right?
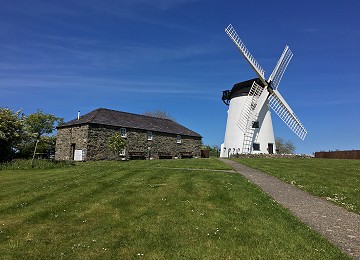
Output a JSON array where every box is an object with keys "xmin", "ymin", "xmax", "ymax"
[{"xmin": 268, "ymin": 90, "xmax": 307, "ymax": 140}]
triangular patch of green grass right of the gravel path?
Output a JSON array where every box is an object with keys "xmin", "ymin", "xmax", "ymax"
[{"xmin": 232, "ymin": 158, "xmax": 360, "ymax": 214}]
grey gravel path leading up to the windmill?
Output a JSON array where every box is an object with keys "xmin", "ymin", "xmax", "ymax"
[{"xmin": 220, "ymin": 159, "xmax": 360, "ymax": 259}]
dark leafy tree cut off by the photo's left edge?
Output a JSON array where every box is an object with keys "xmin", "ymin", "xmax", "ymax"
[{"xmin": 0, "ymin": 108, "xmax": 24, "ymax": 163}]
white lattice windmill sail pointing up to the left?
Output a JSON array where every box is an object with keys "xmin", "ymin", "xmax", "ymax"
[{"xmin": 225, "ymin": 24, "xmax": 267, "ymax": 85}]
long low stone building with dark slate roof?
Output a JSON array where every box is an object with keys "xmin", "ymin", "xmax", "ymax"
[{"xmin": 55, "ymin": 108, "xmax": 202, "ymax": 161}]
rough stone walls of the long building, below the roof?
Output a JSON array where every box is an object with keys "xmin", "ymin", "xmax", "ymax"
[{"xmin": 55, "ymin": 124, "xmax": 201, "ymax": 160}]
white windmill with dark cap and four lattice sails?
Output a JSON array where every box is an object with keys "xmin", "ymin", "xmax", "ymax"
[{"xmin": 220, "ymin": 24, "xmax": 307, "ymax": 157}]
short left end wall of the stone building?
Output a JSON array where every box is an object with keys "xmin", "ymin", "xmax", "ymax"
[{"xmin": 55, "ymin": 125, "xmax": 89, "ymax": 160}]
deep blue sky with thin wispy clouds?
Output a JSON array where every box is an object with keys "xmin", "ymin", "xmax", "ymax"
[{"xmin": 0, "ymin": 0, "xmax": 360, "ymax": 154}]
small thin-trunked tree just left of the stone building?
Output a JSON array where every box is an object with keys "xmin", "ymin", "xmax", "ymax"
[{"xmin": 25, "ymin": 109, "xmax": 63, "ymax": 164}]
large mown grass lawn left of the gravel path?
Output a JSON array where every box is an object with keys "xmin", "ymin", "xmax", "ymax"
[{"xmin": 0, "ymin": 159, "xmax": 348, "ymax": 259}]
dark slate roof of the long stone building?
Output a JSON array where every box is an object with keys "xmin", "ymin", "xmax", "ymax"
[{"xmin": 58, "ymin": 108, "xmax": 202, "ymax": 138}]
